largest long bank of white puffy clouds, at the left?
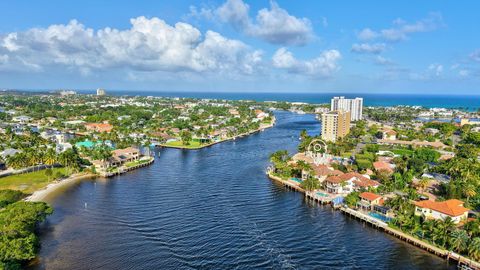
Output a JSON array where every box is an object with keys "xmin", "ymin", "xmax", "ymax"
[{"xmin": 0, "ymin": 16, "xmax": 262, "ymax": 74}]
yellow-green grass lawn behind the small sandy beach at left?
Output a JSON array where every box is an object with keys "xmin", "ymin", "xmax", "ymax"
[{"xmin": 0, "ymin": 168, "xmax": 67, "ymax": 193}]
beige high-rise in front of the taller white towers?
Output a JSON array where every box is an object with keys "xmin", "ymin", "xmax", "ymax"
[{"xmin": 322, "ymin": 111, "xmax": 350, "ymax": 142}]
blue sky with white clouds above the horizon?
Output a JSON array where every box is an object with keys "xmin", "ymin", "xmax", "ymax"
[{"xmin": 0, "ymin": 0, "xmax": 480, "ymax": 94}]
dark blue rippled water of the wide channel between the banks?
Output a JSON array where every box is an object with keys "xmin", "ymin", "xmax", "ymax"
[{"xmin": 34, "ymin": 113, "xmax": 452, "ymax": 269}]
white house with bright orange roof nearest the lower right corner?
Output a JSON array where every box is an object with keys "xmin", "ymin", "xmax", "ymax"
[{"xmin": 415, "ymin": 199, "xmax": 470, "ymax": 224}]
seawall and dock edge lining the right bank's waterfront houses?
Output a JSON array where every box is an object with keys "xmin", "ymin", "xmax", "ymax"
[{"xmin": 267, "ymin": 171, "xmax": 480, "ymax": 270}]
